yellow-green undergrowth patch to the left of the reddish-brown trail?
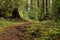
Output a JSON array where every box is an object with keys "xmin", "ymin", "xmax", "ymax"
[{"xmin": 0, "ymin": 18, "xmax": 18, "ymax": 32}]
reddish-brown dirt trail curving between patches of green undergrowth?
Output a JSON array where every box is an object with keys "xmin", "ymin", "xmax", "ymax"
[{"xmin": 0, "ymin": 23, "xmax": 32, "ymax": 40}]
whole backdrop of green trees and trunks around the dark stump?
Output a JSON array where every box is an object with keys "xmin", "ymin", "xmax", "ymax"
[{"xmin": 0, "ymin": 0, "xmax": 60, "ymax": 20}]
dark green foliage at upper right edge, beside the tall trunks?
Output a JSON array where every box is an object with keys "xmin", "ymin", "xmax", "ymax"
[{"xmin": 52, "ymin": 0, "xmax": 60, "ymax": 19}]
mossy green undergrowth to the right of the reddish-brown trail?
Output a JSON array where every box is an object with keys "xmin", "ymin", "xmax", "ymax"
[{"xmin": 27, "ymin": 20, "xmax": 60, "ymax": 40}]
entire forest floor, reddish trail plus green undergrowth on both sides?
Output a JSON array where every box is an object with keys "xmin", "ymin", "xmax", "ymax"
[{"xmin": 0, "ymin": 19, "xmax": 60, "ymax": 40}]
